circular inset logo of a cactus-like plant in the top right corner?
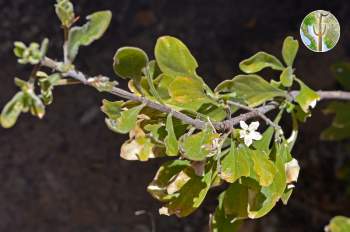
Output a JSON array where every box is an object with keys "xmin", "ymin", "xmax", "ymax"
[{"xmin": 300, "ymin": 10, "xmax": 340, "ymax": 52}]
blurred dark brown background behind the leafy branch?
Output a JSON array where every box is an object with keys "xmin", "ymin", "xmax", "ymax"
[{"xmin": 0, "ymin": 0, "xmax": 350, "ymax": 232}]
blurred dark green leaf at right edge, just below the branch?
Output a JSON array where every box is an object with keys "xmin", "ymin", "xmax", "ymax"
[{"xmin": 321, "ymin": 102, "xmax": 350, "ymax": 141}]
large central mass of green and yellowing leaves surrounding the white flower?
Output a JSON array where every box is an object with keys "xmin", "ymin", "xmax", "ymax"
[{"xmin": 102, "ymin": 36, "xmax": 319, "ymax": 228}]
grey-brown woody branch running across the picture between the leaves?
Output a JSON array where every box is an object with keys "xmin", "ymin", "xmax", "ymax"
[{"xmin": 41, "ymin": 57, "xmax": 350, "ymax": 132}]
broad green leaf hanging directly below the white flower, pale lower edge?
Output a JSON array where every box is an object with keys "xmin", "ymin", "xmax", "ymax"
[{"xmin": 220, "ymin": 142, "xmax": 250, "ymax": 183}]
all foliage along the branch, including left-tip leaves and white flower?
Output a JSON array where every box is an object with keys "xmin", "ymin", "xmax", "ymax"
[{"xmin": 1, "ymin": 0, "xmax": 348, "ymax": 232}]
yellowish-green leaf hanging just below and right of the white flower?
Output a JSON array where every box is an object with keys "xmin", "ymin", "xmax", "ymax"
[{"xmin": 250, "ymin": 150, "xmax": 277, "ymax": 186}]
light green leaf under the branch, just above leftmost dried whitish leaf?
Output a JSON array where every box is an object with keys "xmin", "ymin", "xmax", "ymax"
[{"xmin": 106, "ymin": 105, "xmax": 144, "ymax": 134}]
